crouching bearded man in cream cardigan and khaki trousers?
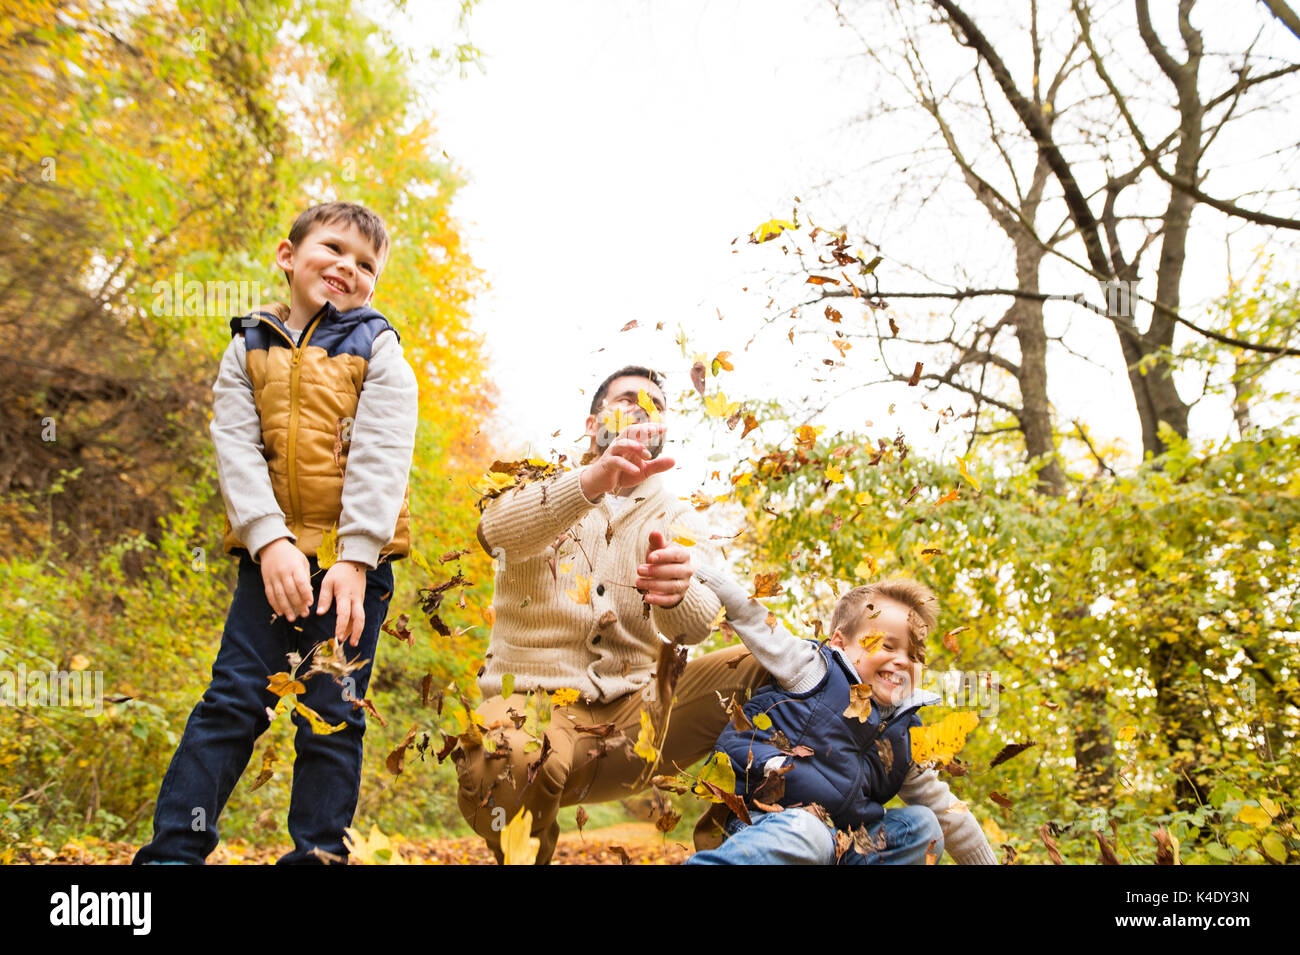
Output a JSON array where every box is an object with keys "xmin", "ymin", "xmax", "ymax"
[{"xmin": 455, "ymin": 366, "xmax": 767, "ymax": 864}]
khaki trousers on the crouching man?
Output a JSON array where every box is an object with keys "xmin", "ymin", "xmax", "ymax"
[{"xmin": 456, "ymin": 646, "xmax": 768, "ymax": 864}]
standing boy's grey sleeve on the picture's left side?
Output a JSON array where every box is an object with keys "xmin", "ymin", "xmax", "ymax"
[{"xmin": 209, "ymin": 334, "xmax": 296, "ymax": 560}]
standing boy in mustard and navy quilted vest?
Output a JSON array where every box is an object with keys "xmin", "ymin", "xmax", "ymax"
[{"xmin": 135, "ymin": 203, "xmax": 417, "ymax": 864}]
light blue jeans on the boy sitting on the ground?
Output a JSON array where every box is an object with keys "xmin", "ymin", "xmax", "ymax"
[{"xmin": 686, "ymin": 806, "xmax": 944, "ymax": 865}]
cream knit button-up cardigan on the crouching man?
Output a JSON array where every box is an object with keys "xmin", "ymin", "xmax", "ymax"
[{"xmin": 478, "ymin": 469, "xmax": 722, "ymax": 703}]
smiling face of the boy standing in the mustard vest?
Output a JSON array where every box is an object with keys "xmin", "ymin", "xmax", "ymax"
[{"xmin": 276, "ymin": 222, "xmax": 384, "ymax": 314}]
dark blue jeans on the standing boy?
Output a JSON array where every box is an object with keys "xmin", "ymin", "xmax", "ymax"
[{"xmin": 134, "ymin": 555, "xmax": 393, "ymax": 864}]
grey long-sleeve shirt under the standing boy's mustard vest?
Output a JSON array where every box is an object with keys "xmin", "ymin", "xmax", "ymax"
[{"xmin": 211, "ymin": 329, "xmax": 420, "ymax": 568}]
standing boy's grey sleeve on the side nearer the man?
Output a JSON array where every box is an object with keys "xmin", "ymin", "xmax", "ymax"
[{"xmin": 338, "ymin": 331, "xmax": 420, "ymax": 568}]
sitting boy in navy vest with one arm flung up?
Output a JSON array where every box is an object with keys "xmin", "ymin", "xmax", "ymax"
[{"xmin": 689, "ymin": 568, "xmax": 997, "ymax": 865}]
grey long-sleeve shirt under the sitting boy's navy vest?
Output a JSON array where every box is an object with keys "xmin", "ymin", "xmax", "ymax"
[{"xmin": 694, "ymin": 567, "xmax": 997, "ymax": 865}]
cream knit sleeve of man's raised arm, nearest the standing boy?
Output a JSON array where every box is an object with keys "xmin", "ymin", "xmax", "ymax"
[{"xmin": 478, "ymin": 468, "xmax": 595, "ymax": 563}]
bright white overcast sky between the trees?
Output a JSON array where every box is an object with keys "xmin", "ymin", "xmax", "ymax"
[{"xmin": 400, "ymin": 0, "xmax": 1294, "ymax": 489}]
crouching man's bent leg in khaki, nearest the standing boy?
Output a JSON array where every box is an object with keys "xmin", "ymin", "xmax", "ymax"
[{"xmin": 454, "ymin": 693, "xmax": 573, "ymax": 865}]
